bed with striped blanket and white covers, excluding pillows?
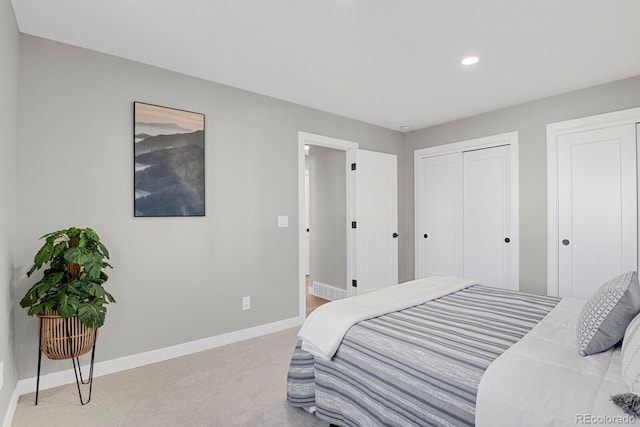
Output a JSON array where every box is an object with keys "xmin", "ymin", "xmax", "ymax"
[{"xmin": 287, "ymin": 277, "xmax": 640, "ymax": 427}]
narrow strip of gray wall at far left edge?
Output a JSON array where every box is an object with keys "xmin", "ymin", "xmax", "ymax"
[{"xmin": 0, "ymin": 0, "xmax": 20, "ymax": 423}]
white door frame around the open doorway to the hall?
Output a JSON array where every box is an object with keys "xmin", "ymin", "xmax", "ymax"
[{"xmin": 298, "ymin": 131, "xmax": 360, "ymax": 320}]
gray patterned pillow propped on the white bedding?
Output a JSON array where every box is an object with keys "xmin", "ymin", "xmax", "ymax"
[{"xmin": 576, "ymin": 271, "xmax": 640, "ymax": 356}]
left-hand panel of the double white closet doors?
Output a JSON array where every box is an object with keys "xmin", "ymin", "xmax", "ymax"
[{"xmin": 416, "ymin": 153, "xmax": 463, "ymax": 278}]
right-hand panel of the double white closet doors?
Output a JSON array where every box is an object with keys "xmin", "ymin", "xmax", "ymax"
[{"xmin": 463, "ymin": 145, "xmax": 515, "ymax": 289}]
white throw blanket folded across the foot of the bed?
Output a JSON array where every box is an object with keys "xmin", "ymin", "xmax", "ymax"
[{"xmin": 298, "ymin": 276, "xmax": 477, "ymax": 360}]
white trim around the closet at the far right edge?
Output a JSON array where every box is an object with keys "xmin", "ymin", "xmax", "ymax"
[{"xmin": 547, "ymin": 107, "xmax": 640, "ymax": 296}]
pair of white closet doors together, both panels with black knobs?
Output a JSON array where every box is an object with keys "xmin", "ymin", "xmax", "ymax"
[{"xmin": 414, "ymin": 132, "xmax": 519, "ymax": 290}]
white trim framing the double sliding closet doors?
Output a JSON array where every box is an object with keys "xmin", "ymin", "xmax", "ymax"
[{"xmin": 413, "ymin": 131, "xmax": 520, "ymax": 290}]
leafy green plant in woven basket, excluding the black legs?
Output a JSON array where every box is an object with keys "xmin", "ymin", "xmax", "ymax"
[{"xmin": 20, "ymin": 227, "xmax": 115, "ymax": 359}]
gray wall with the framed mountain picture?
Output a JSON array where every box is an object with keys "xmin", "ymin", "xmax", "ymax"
[{"xmin": 14, "ymin": 35, "xmax": 404, "ymax": 378}]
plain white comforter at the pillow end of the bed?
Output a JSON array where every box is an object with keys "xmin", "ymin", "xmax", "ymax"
[{"xmin": 476, "ymin": 298, "xmax": 636, "ymax": 427}]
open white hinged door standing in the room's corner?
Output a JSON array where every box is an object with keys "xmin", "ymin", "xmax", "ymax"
[{"xmin": 351, "ymin": 150, "xmax": 398, "ymax": 294}]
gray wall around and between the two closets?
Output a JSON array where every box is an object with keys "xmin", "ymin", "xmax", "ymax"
[{"xmin": 404, "ymin": 76, "xmax": 640, "ymax": 294}]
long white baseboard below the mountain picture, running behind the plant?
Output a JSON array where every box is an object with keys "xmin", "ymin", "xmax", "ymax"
[{"xmin": 16, "ymin": 317, "xmax": 304, "ymax": 395}]
